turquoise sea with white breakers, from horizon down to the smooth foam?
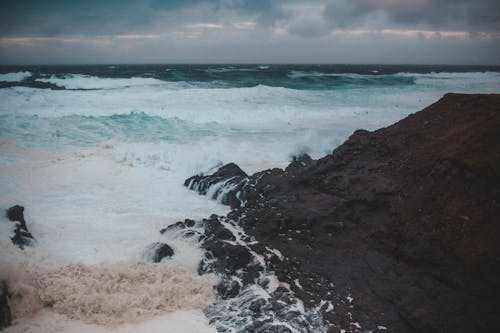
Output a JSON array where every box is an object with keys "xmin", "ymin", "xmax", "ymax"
[{"xmin": 0, "ymin": 65, "xmax": 500, "ymax": 162}]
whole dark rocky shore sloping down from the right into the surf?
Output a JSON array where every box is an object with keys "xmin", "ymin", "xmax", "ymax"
[{"xmin": 185, "ymin": 94, "xmax": 500, "ymax": 332}]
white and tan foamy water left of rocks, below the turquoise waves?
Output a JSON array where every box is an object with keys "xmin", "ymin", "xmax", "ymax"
[{"xmin": 0, "ymin": 142, "xmax": 227, "ymax": 332}]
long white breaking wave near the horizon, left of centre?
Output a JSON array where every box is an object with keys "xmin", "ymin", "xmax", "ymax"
[{"xmin": 35, "ymin": 74, "xmax": 170, "ymax": 89}]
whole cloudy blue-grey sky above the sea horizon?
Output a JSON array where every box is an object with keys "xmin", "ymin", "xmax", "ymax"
[{"xmin": 0, "ymin": 0, "xmax": 500, "ymax": 65}]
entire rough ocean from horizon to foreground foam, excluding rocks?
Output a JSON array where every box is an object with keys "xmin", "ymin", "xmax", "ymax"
[{"xmin": 0, "ymin": 65, "xmax": 500, "ymax": 333}]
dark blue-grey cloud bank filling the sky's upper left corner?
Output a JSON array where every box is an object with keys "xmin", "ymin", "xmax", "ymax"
[{"xmin": 0, "ymin": 0, "xmax": 282, "ymax": 36}]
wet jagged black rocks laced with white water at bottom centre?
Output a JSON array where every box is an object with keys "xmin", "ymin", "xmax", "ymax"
[{"xmin": 161, "ymin": 215, "xmax": 325, "ymax": 333}]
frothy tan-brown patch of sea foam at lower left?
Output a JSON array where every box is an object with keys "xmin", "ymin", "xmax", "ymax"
[{"xmin": 3, "ymin": 262, "xmax": 215, "ymax": 325}]
